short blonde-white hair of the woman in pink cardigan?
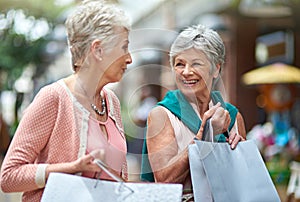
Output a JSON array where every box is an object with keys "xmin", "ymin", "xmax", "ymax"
[{"xmin": 65, "ymin": 0, "xmax": 130, "ymax": 70}]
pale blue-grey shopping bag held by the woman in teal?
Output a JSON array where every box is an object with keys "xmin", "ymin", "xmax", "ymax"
[{"xmin": 189, "ymin": 140, "xmax": 280, "ymax": 202}]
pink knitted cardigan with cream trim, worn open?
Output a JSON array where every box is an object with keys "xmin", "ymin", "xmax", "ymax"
[{"xmin": 0, "ymin": 80, "xmax": 127, "ymax": 202}]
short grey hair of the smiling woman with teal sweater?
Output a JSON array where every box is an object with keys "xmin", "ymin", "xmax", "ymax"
[{"xmin": 170, "ymin": 25, "xmax": 225, "ymax": 72}]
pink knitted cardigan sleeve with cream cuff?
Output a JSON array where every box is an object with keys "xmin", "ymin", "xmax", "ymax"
[{"xmin": 0, "ymin": 86, "xmax": 59, "ymax": 192}]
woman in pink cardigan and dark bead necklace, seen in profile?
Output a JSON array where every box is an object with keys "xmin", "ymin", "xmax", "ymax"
[{"xmin": 1, "ymin": 0, "xmax": 132, "ymax": 202}]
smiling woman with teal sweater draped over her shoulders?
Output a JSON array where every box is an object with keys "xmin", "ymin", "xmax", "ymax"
[{"xmin": 141, "ymin": 25, "xmax": 246, "ymax": 200}]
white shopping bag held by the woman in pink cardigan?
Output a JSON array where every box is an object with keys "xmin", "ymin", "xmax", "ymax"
[{"xmin": 41, "ymin": 173, "xmax": 182, "ymax": 202}]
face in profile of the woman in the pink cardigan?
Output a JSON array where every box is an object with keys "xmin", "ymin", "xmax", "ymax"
[{"xmin": 103, "ymin": 28, "xmax": 132, "ymax": 83}]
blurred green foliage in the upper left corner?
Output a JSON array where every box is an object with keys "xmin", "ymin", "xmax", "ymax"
[{"xmin": 0, "ymin": 0, "xmax": 74, "ymax": 91}]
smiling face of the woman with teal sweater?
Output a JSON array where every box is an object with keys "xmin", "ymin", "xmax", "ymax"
[{"xmin": 174, "ymin": 48, "xmax": 219, "ymax": 101}]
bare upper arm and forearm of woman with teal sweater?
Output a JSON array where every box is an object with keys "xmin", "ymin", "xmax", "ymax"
[{"xmin": 147, "ymin": 107, "xmax": 189, "ymax": 183}]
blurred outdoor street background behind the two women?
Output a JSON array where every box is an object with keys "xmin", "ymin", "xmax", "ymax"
[{"xmin": 0, "ymin": 0, "xmax": 300, "ymax": 199}]
